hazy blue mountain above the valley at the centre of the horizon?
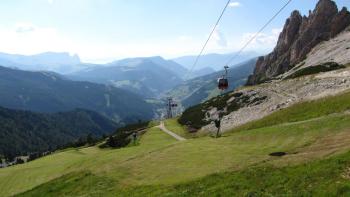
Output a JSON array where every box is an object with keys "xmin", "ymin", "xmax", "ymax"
[{"xmin": 67, "ymin": 57, "xmax": 187, "ymax": 97}]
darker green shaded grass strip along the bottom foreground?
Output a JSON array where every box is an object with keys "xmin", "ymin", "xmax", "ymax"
[{"xmin": 34, "ymin": 149, "xmax": 350, "ymax": 197}]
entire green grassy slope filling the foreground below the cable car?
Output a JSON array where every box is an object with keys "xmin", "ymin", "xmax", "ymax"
[{"xmin": 0, "ymin": 90, "xmax": 350, "ymax": 196}]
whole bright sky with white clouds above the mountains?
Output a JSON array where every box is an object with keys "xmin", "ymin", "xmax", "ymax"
[{"xmin": 0, "ymin": 0, "xmax": 350, "ymax": 62}]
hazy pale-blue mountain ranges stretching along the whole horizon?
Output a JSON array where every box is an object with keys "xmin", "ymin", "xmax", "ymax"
[{"xmin": 0, "ymin": 52, "xmax": 257, "ymax": 101}]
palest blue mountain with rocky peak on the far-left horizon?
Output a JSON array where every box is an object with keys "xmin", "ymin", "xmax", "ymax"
[{"xmin": 0, "ymin": 52, "xmax": 82, "ymax": 74}]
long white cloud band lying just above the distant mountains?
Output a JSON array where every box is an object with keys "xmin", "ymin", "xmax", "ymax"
[{"xmin": 0, "ymin": 18, "xmax": 281, "ymax": 62}]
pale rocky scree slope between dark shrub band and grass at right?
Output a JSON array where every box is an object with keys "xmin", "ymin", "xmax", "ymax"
[{"xmin": 202, "ymin": 67, "xmax": 350, "ymax": 133}]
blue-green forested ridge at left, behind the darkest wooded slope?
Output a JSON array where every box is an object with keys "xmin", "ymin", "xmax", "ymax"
[{"xmin": 0, "ymin": 67, "xmax": 154, "ymax": 124}]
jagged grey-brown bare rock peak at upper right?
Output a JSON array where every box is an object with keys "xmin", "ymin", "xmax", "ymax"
[{"xmin": 247, "ymin": 0, "xmax": 350, "ymax": 85}]
